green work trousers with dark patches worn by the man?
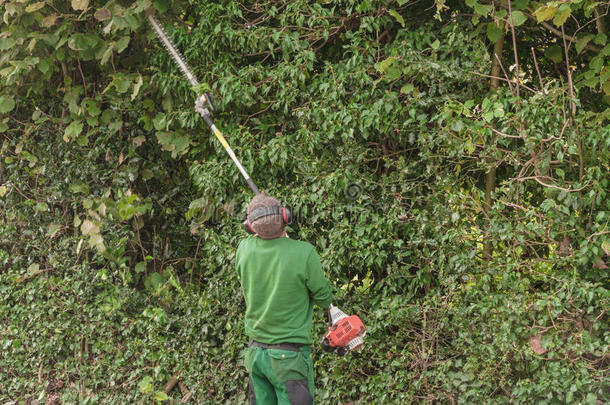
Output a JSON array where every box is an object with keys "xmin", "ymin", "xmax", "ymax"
[{"xmin": 245, "ymin": 346, "xmax": 314, "ymax": 405}]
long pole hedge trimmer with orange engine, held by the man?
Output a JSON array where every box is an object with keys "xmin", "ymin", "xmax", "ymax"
[{"xmin": 146, "ymin": 12, "xmax": 366, "ymax": 356}]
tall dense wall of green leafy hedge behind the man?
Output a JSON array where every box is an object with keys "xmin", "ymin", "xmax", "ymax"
[{"xmin": 0, "ymin": 0, "xmax": 610, "ymax": 404}]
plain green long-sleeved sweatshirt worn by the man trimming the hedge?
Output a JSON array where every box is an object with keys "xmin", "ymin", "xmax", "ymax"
[{"xmin": 235, "ymin": 236, "xmax": 332, "ymax": 344}]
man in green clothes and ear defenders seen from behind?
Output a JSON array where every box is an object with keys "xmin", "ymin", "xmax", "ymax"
[{"xmin": 235, "ymin": 194, "xmax": 332, "ymax": 405}]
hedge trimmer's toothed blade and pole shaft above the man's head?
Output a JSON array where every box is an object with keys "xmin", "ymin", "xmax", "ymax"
[{"xmin": 147, "ymin": 13, "xmax": 260, "ymax": 194}]
